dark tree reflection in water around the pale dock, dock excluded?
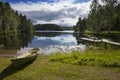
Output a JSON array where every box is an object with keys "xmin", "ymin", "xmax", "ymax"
[{"xmin": 74, "ymin": 33, "xmax": 120, "ymax": 50}]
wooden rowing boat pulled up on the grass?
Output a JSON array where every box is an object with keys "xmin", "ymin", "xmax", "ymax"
[{"xmin": 11, "ymin": 48, "xmax": 39, "ymax": 68}]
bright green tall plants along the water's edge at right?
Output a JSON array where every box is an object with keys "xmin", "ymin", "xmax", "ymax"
[{"xmin": 50, "ymin": 50, "xmax": 120, "ymax": 67}]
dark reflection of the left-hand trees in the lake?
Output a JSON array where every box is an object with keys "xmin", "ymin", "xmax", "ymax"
[{"xmin": 0, "ymin": 33, "xmax": 33, "ymax": 56}]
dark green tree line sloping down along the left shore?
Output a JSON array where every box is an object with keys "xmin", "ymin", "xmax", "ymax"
[{"xmin": 0, "ymin": 1, "xmax": 34, "ymax": 33}]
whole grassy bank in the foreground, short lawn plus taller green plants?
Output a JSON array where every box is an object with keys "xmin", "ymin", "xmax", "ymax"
[{"xmin": 0, "ymin": 50, "xmax": 120, "ymax": 80}]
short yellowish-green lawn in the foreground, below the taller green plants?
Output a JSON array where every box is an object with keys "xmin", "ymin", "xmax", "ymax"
[{"xmin": 0, "ymin": 53, "xmax": 120, "ymax": 80}]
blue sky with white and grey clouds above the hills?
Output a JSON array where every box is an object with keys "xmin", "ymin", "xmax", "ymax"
[{"xmin": 4, "ymin": 0, "xmax": 91, "ymax": 26}]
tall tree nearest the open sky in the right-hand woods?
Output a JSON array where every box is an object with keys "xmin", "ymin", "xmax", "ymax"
[{"xmin": 87, "ymin": 0, "xmax": 100, "ymax": 32}]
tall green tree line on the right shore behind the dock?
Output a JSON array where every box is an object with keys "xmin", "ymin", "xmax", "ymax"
[{"xmin": 74, "ymin": 0, "xmax": 120, "ymax": 34}]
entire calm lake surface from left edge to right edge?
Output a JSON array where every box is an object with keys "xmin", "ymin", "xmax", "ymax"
[{"xmin": 0, "ymin": 31, "xmax": 120, "ymax": 56}]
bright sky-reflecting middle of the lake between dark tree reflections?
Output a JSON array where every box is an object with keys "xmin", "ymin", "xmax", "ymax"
[{"xmin": 18, "ymin": 31, "xmax": 85, "ymax": 54}]
